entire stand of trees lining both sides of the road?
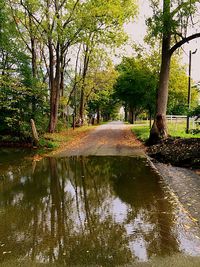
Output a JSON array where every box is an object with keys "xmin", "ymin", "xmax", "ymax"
[{"xmin": 0, "ymin": 0, "xmax": 200, "ymax": 142}]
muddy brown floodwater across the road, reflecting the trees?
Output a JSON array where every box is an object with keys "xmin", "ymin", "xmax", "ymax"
[{"xmin": 0, "ymin": 151, "xmax": 200, "ymax": 266}]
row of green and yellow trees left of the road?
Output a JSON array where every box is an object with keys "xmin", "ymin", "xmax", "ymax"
[{"xmin": 0, "ymin": 0, "xmax": 136, "ymax": 141}]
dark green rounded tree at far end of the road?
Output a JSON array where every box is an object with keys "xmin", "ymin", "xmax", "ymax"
[{"xmin": 115, "ymin": 56, "xmax": 157, "ymax": 123}]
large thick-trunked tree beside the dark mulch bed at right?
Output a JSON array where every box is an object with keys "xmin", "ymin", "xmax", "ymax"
[{"xmin": 148, "ymin": 0, "xmax": 200, "ymax": 143}]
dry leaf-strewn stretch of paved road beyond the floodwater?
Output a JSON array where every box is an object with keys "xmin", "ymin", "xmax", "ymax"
[{"xmin": 57, "ymin": 121, "xmax": 144, "ymax": 157}]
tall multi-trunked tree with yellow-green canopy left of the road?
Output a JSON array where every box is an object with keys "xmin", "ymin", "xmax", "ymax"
[{"xmin": 8, "ymin": 0, "xmax": 136, "ymax": 132}]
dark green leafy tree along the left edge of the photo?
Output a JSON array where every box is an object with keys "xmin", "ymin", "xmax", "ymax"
[{"xmin": 0, "ymin": 1, "xmax": 47, "ymax": 140}]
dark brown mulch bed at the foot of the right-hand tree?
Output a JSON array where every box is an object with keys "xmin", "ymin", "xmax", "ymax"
[{"xmin": 147, "ymin": 137, "xmax": 200, "ymax": 169}]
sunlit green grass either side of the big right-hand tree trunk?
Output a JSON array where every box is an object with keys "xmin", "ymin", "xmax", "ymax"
[{"xmin": 132, "ymin": 122, "xmax": 200, "ymax": 142}]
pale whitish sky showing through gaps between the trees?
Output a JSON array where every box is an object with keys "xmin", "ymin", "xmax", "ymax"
[{"xmin": 125, "ymin": 0, "xmax": 200, "ymax": 82}]
